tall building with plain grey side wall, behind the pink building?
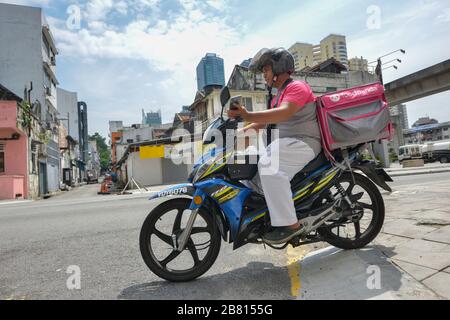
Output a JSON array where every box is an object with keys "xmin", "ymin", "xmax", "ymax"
[{"xmin": 0, "ymin": 3, "xmax": 60, "ymax": 195}]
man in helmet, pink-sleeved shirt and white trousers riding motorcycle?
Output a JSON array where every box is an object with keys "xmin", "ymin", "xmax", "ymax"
[{"xmin": 228, "ymin": 48, "xmax": 322, "ymax": 244}]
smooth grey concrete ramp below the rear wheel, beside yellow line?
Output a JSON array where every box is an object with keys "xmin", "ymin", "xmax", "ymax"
[{"xmin": 297, "ymin": 245, "xmax": 442, "ymax": 300}]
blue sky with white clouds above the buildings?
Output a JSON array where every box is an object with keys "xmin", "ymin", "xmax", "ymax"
[{"xmin": 0, "ymin": 0, "xmax": 450, "ymax": 136}]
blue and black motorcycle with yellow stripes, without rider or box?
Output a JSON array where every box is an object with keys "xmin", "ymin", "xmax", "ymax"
[{"xmin": 139, "ymin": 87, "xmax": 392, "ymax": 282}]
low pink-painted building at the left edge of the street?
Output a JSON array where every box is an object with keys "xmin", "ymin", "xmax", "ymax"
[{"xmin": 0, "ymin": 101, "xmax": 28, "ymax": 199}]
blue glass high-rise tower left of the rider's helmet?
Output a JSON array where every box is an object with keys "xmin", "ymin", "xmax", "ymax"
[{"xmin": 197, "ymin": 53, "xmax": 225, "ymax": 91}]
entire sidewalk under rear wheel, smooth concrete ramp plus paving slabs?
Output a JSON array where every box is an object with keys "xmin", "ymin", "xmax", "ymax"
[{"xmin": 297, "ymin": 176, "xmax": 450, "ymax": 300}]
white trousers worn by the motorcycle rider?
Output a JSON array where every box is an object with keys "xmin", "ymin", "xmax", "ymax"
[{"xmin": 247, "ymin": 138, "xmax": 316, "ymax": 227}]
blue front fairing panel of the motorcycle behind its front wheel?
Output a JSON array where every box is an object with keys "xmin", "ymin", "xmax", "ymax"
[{"xmin": 194, "ymin": 178, "xmax": 252, "ymax": 240}]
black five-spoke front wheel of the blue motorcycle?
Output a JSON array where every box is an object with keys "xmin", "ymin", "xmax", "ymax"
[{"xmin": 139, "ymin": 198, "xmax": 221, "ymax": 282}]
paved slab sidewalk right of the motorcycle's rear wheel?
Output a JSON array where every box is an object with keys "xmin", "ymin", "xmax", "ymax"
[{"xmin": 375, "ymin": 182, "xmax": 450, "ymax": 299}]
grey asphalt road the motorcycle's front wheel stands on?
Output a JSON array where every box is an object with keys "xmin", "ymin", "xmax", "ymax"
[{"xmin": 0, "ymin": 173, "xmax": 450, "ymax": 300}]
